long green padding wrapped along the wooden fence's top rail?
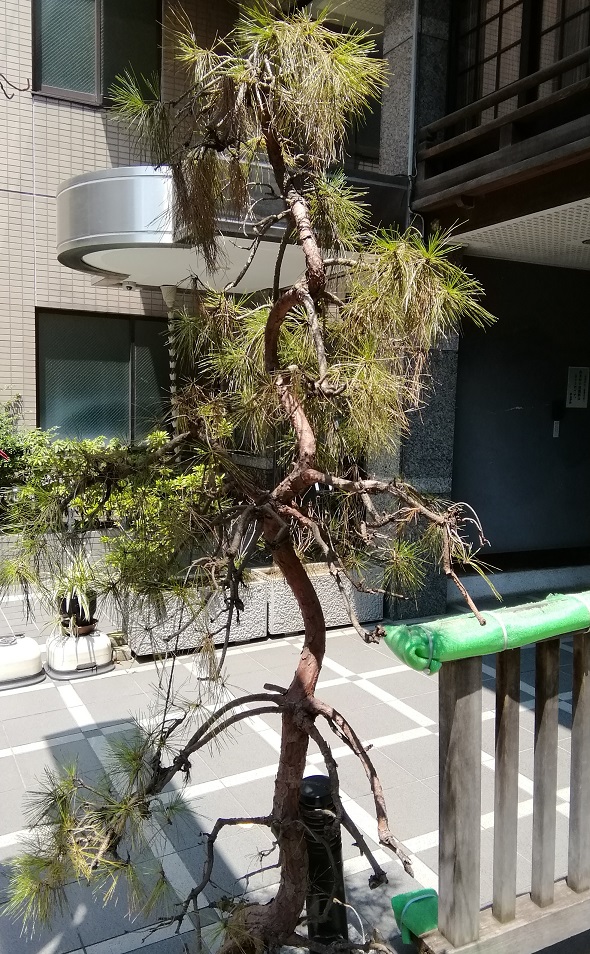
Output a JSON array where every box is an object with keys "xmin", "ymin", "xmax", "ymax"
[{"xmin": 384, "ymin": 591, "xmax": 590, "ymax": 672}]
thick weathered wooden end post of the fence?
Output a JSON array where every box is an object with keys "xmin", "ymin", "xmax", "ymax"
[{"xmin": 438, "ymin": 657, "xmax": 481, "ymax": 947}]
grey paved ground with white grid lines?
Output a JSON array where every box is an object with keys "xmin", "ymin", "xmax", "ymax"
[{"xmin": 0, "ymin": 601, "xmax": 586, "ymax": 954}]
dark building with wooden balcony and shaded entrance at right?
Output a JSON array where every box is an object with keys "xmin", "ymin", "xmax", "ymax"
[{"xmin": 412, "ymin": 0, "xmax": 590, "ymax": 591}]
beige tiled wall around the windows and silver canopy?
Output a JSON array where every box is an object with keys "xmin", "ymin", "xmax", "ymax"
[{"xmin": 0, "ymin": 0, "xmax": 235, "ymax": 426}]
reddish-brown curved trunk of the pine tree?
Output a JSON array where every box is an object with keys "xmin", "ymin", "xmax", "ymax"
[{"xmin": 221, "ymin": 128, "xmax": 336, "ymax": 954}]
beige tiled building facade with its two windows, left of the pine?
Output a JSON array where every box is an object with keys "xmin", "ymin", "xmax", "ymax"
[{"xmin": 0, "ymin": 0, "xmax": 235, "ymax": 438}]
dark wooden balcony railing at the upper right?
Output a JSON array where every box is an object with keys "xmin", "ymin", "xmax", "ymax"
[{"xmin": 413, "ymin": 47, "xmax": 590, "ymax": 211}]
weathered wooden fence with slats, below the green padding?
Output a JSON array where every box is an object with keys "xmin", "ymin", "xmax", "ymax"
[{"xmin": 421, "ymin": 633, "xmax": 590, "ymax": 954}]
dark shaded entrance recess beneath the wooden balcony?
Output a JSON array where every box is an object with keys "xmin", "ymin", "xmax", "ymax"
[{"xmin": 453, "ymin": 259, "xmax": 590, "ymax": 555}]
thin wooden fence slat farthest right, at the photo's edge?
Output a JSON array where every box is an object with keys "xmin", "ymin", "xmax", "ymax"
[{"xmin": 567, "ymin": 633, "xmax": 590, "ymax": 891}]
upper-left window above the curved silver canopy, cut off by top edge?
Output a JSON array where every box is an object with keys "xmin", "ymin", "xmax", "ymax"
[{"xmin": 33, "ymin": 0, "xmax": 161, "ymax": 104}]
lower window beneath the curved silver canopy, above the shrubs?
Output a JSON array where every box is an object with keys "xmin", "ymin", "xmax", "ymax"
[{"xmin": 37, "ymin": 312, "xmax": 170, "ymax": 441}]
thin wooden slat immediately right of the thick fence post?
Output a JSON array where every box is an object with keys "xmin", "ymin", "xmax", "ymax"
[{"xmin": 492, "ymin": 649, "xmax": 520, "ymax": 922}]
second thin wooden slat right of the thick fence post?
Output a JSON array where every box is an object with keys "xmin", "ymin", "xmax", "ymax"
[{"xmin": 531, "ymin": 639, "xmax": 559, "ymax": 907}]
